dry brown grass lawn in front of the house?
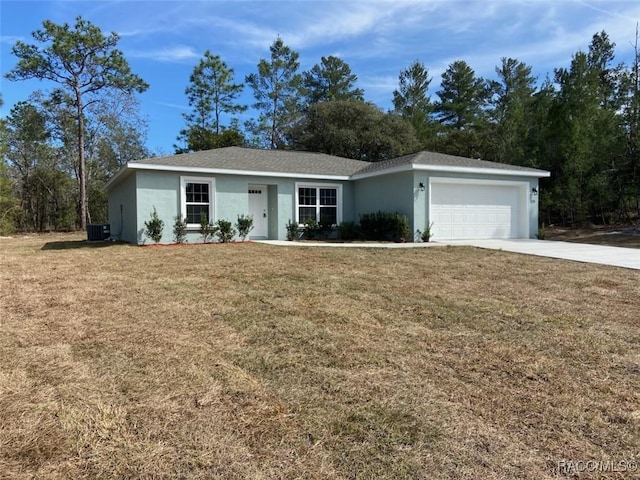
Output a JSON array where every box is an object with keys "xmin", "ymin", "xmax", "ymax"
[{"xmin": 0, "ymin": 236, "xmax": 640, "ymax": 479}]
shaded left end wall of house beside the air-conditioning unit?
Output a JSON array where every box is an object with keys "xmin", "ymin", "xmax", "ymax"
[{"xmin": 108, "ymin": 172, "xmax": 138, "ymax": 243}]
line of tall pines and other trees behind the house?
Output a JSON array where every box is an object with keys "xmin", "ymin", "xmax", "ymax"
[{"xmin": 0, "ymin": 17, "xmax": 640, "ymax": 232}]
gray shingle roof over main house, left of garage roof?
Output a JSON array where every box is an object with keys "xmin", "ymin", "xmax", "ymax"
[{"xmin": 131, "ymin": 147, "xmax": 369, "ymax": 177}]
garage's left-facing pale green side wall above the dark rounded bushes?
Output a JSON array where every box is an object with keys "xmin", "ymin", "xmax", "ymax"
[{"xmin": 352, "ymin": 172, "xmax": 424, "ymax": 238}]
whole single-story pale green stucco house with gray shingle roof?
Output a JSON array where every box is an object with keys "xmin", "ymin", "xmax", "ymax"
[{"xmin": 106, "ymin": 147, "xmax": 549, "ymax": 243}]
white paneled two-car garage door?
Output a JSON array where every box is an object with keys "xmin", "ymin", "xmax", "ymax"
[{"xmin": 430, "ymin": 182, "xmax": 525, "ymax": 241}]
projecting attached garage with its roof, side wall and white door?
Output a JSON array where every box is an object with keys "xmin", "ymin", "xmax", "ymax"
[{"xmin": 351, "ymin": 152, "xmax": 550, "ymax": 242}]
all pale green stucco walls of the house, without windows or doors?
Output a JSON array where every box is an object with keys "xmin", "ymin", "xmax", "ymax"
[{"xmin": 109, "ymin": 170, "xmax": 539, "ymax": 243}]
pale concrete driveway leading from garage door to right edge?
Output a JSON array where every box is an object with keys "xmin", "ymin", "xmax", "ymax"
[{"xmin": 438, "ymin": 239, "xmax": 640, "ymax": 270}]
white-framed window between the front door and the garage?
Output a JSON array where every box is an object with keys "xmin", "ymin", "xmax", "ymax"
[{"xmin": 296, "ymin": 184, "xmax": 342, "ymax": 225}]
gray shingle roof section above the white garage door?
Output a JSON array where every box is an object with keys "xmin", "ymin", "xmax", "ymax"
[{"xmin": 357, "ymin": 152, "xmax": 543, "ymax": 174}]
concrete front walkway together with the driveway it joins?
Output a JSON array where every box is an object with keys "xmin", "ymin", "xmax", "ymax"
[{"xmin": 258, "ymin": 239, "xmax": 640, "ymax": 270}]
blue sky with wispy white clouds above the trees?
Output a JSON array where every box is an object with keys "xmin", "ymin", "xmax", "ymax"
[{"xmin": 0, "ymin": 0, "xmax": 640, "ymax": 154}]
